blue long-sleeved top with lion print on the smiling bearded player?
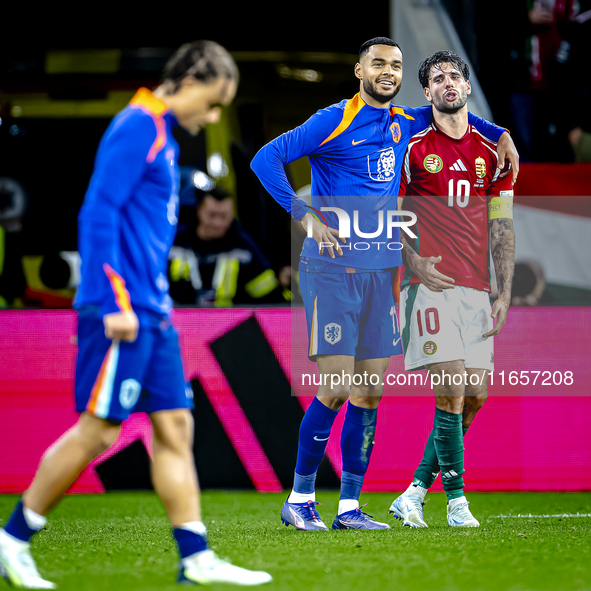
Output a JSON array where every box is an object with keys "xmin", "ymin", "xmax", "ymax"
[{"xmin": 251, "ymin": 93, "xmax": 505, "ymax": 269}]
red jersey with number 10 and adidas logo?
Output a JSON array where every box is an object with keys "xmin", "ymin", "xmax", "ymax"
[{"xmin": 399, "ymin": 124, "xmax": 513, "ymax": 291}]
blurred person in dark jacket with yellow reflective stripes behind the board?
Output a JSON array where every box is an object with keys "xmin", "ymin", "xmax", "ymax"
[{"xmin": 169, "ymin": 173, "xmax": 291, "ymax": 307}]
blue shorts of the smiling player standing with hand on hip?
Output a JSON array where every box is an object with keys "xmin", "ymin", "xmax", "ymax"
[{"xmin": 299, "ymin": 265, "xmax": 402, "ymax": 361}]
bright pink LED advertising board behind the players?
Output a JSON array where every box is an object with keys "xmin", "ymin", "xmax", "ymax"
[{"xmin": 0, "ymin": 307, "xmax": 591, "ymax": 493}]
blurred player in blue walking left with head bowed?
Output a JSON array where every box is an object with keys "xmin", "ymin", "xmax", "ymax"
[{"xmin": 0, "ymin": 41, "xmax": 271, "ymax": 589}]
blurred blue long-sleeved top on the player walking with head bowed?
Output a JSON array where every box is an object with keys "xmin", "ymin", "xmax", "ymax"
[{"xmin": 75, "ymin": 88, "xmax": 179, "ymax": 315}]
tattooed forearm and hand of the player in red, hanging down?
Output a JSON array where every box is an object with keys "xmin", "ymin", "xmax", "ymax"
[{"xmin": 482, "ymin": 218, "xmax": 515, "ymax": 338}]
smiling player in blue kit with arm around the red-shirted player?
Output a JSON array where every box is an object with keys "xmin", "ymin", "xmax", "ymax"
[{"xmin": 251, "ymin": 37, "xmax": 518, "ymax": 531}]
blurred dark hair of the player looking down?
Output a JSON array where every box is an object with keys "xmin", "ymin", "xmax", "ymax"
[{"xmin": 162, "ymin": 41, "xmax": 238, "ymax": 88}]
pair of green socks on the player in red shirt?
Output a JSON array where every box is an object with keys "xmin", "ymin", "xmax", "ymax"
[{"xmin": 413, "ymin": 408, "xmax": 468, "ymax": 499}]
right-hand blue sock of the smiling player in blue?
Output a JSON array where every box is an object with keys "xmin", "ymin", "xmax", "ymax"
[{"xmin": 341, "ymin": 400, "xmax": 378, "ymax": 501}]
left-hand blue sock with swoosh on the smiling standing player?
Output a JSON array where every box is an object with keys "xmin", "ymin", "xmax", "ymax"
[{"xmin": 293, "ymin": 398, "xmax": 339, "ymax": 494}]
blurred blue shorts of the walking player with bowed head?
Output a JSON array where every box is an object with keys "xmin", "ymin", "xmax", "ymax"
[{"xmin": 75, "ymin": 306, "xmax": 193, "ymax": 422}]
